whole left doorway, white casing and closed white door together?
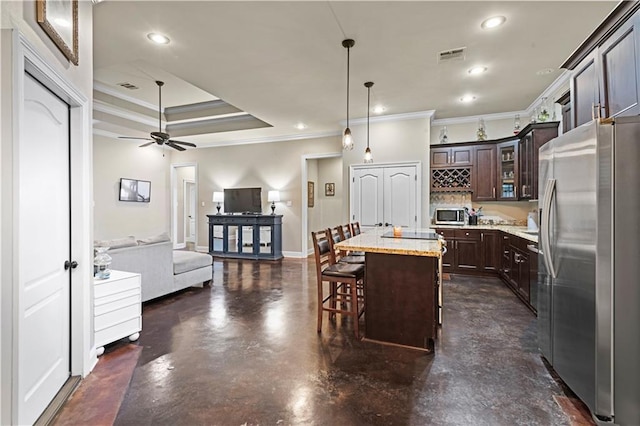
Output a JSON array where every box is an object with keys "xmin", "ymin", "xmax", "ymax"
[{"xmin": 0, "ymin": 34, "xmax": 96, "ymax": 424}]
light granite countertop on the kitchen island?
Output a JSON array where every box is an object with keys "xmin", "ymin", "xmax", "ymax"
[{"xmin": 336, "ymin": 228, "xmax": 444, "ymax": 257}]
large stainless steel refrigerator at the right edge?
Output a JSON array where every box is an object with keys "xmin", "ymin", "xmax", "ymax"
[{"xmin": 538, "ymin": 116, "xmax": 640, "ymax": 425}]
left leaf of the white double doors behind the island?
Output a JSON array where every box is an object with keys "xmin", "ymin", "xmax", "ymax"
[{"xmin": 351, "ymin": 168, "xmax": 384, "ymax": 229}]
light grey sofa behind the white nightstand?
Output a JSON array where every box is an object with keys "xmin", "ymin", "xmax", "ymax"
[{"xmin": 94, "ymin": 234, "xmax": 213, "ymax": 302}]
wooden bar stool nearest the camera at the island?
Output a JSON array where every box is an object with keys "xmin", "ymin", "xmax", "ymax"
[{"xmin": 311, "ymin": 229, "xmax": 364, "ymax": 338}]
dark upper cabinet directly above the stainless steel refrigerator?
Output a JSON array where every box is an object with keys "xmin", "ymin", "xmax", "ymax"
[{"xmin": 561, "ymin": 2, "xmax": 640, "ymax": 128}]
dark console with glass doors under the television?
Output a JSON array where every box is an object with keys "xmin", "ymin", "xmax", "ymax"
[{"xmin": 207, "ymin": 214, "xmax": 282, "ymax": 260}]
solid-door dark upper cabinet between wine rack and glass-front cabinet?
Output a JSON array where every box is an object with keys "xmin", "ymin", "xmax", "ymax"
[{"xmin": 471, "ymin": 144, "xmax": 498, "ymax": 201}]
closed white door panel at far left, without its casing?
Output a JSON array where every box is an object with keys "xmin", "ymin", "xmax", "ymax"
[{"xmin": 15, "ymin": 74, "xmax": 71, "ymax": 424}]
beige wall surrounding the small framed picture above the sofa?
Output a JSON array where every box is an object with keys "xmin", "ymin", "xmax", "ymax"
[{"xmin": 93, "ymin": 135, "xmax": 171, "ymax": 240}]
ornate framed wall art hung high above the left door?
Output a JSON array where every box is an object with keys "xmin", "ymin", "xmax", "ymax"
[{"xmin": 36, "ymin": 0, "xmax": 78, "ymax": 65}]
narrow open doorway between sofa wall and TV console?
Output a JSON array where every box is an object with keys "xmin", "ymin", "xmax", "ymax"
[{"xmin": 171, "ymin": 163, "xmax": 198, "ymax": 250}]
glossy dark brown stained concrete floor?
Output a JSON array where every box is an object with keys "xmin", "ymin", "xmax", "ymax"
[{"xmin": 105, "ymin": 259, "xmax": 575, "ymax": 426}]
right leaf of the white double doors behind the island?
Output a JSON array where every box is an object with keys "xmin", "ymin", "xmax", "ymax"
[{"xmin": 383, "ymin": 166, "xmax": 418, "ymax": 228}]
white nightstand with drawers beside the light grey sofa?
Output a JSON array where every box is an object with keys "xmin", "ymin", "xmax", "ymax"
[{"xmin": 93, "ymin": 271, "xmax": 142, "ymax": 356}]
